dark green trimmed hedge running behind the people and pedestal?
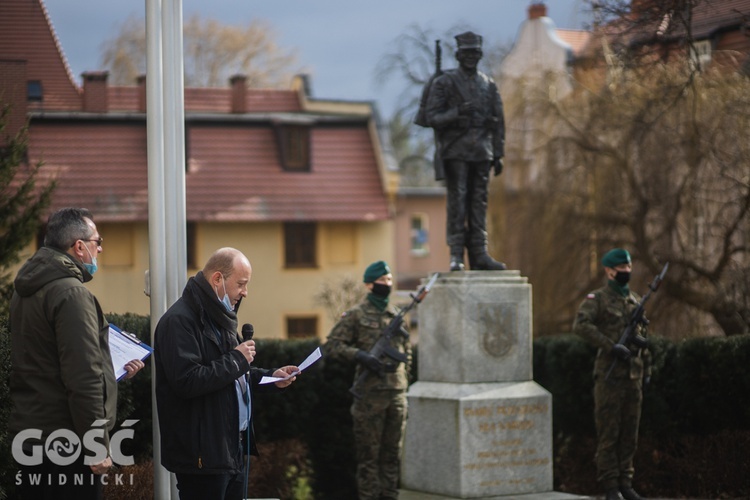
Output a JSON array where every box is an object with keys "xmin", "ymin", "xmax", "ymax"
[{"xmin": 0, "ymin": 314, "xmax": 750, "ymax": 500}]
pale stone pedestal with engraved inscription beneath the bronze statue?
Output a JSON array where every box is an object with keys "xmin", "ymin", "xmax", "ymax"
[{"xmin": 401, "ymin": 271, "xmax": 553, "ymax": 499}]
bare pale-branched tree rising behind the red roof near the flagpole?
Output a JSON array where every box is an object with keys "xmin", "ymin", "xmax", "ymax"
[{"xmin": 102, "ymin": 16, "xmax": 304, "ymax": 88}]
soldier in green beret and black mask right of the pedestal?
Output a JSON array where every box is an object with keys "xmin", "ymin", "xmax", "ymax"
[{"xmin": 573, "ymin": 248, "xmax": 651, "ymax": 500}]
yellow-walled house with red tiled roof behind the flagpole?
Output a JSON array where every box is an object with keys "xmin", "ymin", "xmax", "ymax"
[{"xmin": 0, "ymin": 0, "xmax": 398, "ymax": 338}]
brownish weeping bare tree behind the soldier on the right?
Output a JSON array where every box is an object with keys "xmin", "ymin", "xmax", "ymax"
[{"xmin": 506, "ymin": 53, "xmax": 750, "ymax": 336}]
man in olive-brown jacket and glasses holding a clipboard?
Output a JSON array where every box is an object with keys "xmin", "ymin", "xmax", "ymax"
[{"xmin": 9, "ymin": 208, "xmax": 144, "ymax": 500}]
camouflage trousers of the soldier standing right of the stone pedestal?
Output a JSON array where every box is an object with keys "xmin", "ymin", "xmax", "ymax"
[{"xmin": 594, "ymin": 376, "xmax": 643, "ymax": 489}]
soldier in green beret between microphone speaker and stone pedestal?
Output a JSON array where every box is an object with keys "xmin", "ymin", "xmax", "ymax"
[{"xmin": 324, "ymin": 261, "xmax": 411, "ymax": 500}]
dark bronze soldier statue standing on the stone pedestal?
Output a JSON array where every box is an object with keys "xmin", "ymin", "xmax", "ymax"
[{"xmin": 416, "ymin": 31, "xmax": 506, "ymax": 271}]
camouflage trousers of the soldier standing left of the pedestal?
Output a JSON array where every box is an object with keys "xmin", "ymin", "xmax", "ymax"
[{"xmin": 351, "ymin": 390, "xmax": 407, "ymax": 500}]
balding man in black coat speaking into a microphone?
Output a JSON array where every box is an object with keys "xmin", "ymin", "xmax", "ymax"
[{"xmin": 154, "ymin": 248, "xmax": 297, "ymax": 500}]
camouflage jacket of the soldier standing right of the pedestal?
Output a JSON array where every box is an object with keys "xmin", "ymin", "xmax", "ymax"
[{"xmin": 573, "ymin": 286, "xmax": 651, "ymax": 380}]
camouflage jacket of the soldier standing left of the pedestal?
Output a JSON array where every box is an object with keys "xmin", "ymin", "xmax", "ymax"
[{"xmin": 323, "ymin": 301, "xmax": 411, "ymax": 393}]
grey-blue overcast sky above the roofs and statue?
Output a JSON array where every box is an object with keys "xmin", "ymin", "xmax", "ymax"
[{"xmin": 44, "ymin": 0, "xmax": 589, "ymax": 116}]
